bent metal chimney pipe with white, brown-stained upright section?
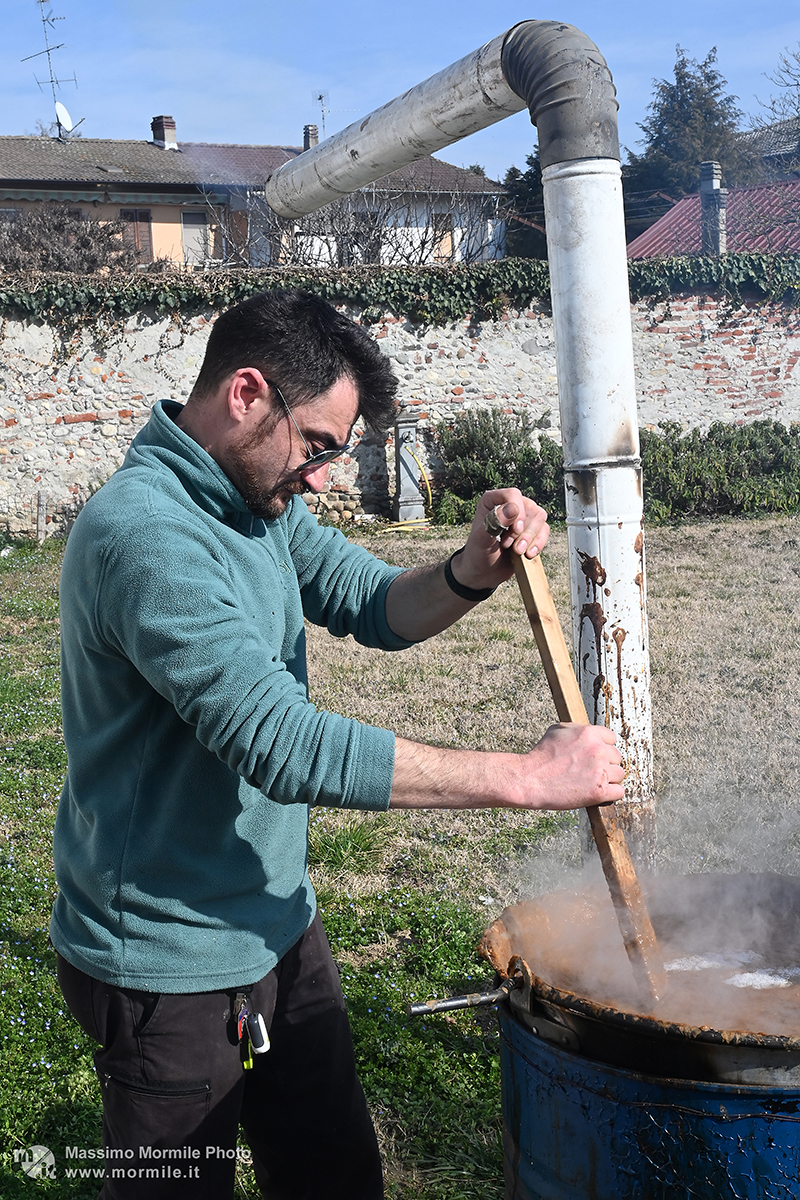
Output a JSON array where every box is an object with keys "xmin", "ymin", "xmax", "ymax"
[{"xmin": 266, "ymin": 20, "xmax": 655, "ymax": 865}]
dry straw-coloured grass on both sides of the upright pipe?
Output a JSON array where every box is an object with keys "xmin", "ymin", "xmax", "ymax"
[{"xmin": 308, "ymin": 516, "xmax": 800, "ymax": 907}]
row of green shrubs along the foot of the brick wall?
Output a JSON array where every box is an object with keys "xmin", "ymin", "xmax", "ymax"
[{"xmin": 434, "ymin": 410, "xmax": 800, "ymax": 524}]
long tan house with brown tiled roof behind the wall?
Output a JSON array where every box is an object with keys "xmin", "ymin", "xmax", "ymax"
[{"xmin": 0, "ymin": 116, "xmax": 505, "ymax": 266}]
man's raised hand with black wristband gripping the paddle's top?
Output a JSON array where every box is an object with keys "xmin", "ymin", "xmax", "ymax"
[{"xmin": 451, "ymin": 487, "xmax": 551, "ymax": 588}]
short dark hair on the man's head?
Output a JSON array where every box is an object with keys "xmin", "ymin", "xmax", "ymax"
[{"xmin": 192, "ymin": 290, "xmax": 397, "ymax": 430}]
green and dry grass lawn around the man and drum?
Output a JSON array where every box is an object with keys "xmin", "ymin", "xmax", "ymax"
[{"xmin": 0, "ymin": 516, "xmax": 800, "ymax": 1200}]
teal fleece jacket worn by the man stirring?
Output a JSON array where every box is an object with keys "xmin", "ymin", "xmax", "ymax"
[{"xmin": 50, "ymin": 401, "xmax": 409, "ymax": 992}]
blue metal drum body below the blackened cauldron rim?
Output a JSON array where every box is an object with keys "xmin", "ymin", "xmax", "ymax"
[{"xmin": 500, "ymin": 1009, "xmax": 800, "ymax": 1200}]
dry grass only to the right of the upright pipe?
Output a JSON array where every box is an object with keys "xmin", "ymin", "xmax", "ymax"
[{"xmin": 648, "ymin": 516, "xmax": 800, "ymax": 872}]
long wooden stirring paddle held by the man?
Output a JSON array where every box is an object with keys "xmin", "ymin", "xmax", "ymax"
[{"xmin": 506, "ymin": 544, "xmax": 667, "ymax": 1003}]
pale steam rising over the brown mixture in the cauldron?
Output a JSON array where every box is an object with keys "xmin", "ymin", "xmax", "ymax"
[{"xmin": 494, "ymin": 830, "xmax": 800, "ymax": 1037}]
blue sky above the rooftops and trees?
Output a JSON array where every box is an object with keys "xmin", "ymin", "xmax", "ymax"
[{"xmin": 0, "ymin": 0, "xmax": 800, "ymax": 178}]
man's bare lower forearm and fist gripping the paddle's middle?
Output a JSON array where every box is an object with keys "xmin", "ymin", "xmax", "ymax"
[{"xmin": 390, "ymin": 725, "xmax": 625, "ymax": 809}]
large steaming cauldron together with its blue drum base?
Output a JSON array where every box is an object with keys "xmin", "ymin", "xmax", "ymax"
[{"xmin": 482, "ymin": 875, "xmax": 800, "ymax": 1200}]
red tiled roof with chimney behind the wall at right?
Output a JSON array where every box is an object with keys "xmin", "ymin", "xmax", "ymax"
[{"xmin": 627, "ymin": 162, "xmax": 800, "ymax": 258}]
